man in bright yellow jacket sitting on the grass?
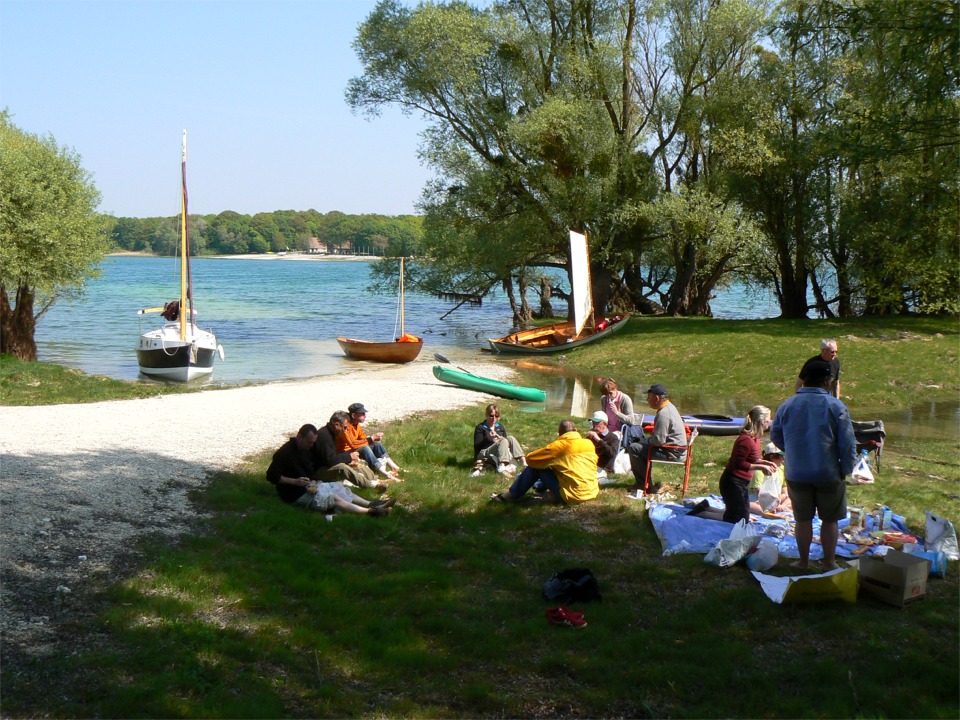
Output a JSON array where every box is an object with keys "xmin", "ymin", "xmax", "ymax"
[{"xmin": 490, "ymin": 420, "xmax": 600, "ymax": 505}]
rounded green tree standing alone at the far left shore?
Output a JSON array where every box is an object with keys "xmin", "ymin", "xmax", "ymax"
[{"xmin": 0, "ymin": 116, "xmax": 108, "ymax": 360}]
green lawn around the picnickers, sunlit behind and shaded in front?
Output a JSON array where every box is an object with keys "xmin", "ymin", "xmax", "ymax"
[{"xmin": 3, "ymin": 319, "xmax": 960, "ymax": 717}]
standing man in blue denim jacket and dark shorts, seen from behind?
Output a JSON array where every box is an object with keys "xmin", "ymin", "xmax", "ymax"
[{"xmin": 770, "ymin": 358, "xmax": 857, "ymax": 570}]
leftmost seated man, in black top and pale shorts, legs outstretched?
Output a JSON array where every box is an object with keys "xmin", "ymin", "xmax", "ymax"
[{"xmin": 267, "ymin": 425, "xmax": 396, "ymax": 517}]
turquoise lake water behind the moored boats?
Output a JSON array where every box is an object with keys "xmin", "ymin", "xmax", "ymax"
[{"xmin": 36, "ymin": 257, "xmax": 779, "ymax": 385}]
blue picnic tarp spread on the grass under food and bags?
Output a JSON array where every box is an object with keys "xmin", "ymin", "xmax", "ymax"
[{"xmin": 647, "ymin": 495, "xmax": 919, "ymax": 560}]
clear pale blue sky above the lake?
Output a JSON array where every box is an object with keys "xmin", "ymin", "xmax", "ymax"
[{"xmin": 0, "ymin": 0, "xmax": 430, "ymax": 217}]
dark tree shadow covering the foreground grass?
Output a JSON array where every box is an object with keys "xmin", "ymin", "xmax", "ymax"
[{"xmin": 4, "ymin": 458, "xmax": 958, "ymax": 717}]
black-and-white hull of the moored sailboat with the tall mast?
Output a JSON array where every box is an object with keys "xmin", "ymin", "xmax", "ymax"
[{"xmin": 137, "ymin": 323, "xmax": 218, "ymax": 382}]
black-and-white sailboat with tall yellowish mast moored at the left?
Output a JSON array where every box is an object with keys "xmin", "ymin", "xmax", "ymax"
[{"xmin": 137, "ymin": 130, "xmax": 224, "ymax": 382}]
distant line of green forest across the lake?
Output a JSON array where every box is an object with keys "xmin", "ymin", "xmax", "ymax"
[{"xmin": 110, "ymin": 210, "xmax": 423, "ymax": 256}]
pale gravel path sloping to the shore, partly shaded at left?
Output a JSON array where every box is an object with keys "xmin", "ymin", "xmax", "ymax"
[{"xmin": 0, "ymin": 359, "xmax": 511, "ymax": 661}]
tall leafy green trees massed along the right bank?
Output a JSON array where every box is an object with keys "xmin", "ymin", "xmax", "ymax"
[{"xmin": 347, "ymin": 0, "xmax": 960, "ymax": 320}]
